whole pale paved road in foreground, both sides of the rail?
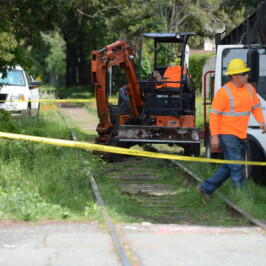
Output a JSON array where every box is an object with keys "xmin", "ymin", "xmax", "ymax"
[{"xmin": 0, "ymin": 222, "xmax": 266, "ymax": 266}]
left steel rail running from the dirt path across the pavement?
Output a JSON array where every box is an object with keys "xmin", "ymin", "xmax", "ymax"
[{"xmin": 58, "ymin": 110, "xmax": 131, "ymax": 266}]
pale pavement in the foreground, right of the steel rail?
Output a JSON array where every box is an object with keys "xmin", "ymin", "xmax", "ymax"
[{"xmin": 119, "ymin": 224, "xmax": 266, "ymax": 266}]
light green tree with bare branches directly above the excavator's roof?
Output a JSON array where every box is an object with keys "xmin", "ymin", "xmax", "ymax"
[{"xmin": 110, "ymin": 0, "xmax": 243, "ymax": 51}]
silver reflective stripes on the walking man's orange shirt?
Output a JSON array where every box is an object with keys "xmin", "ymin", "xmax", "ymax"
[{"xmin": 210, "ymin": 83, "xmax": 254, "ymax": 116}]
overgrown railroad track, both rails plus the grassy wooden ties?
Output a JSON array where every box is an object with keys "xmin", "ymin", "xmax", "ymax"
[{"xmin": 59, "ymin": 109, "xmax": 266, "ymax": 265}]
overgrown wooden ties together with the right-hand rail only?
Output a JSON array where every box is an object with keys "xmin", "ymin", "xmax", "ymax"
[{"xmin": 106, "ymin": 158, "xmax": 266, "ymax": 230}]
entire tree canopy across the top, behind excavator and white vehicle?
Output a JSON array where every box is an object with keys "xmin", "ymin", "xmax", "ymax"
[{"xmin": 0, "ymin": 0, "xmax": 260, "ymax": 86}]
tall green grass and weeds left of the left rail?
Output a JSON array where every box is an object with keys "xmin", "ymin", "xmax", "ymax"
[{"xmin": 0, "ymin": 95, "xmax": 102, "ymax": 221}]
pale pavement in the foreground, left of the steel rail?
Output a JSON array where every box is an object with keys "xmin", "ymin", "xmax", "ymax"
[{"xmin": 0, "ymin": 222, "xmax": 120, "ymax": 266}]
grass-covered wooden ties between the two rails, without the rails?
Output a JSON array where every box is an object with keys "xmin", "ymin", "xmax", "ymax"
[{"xmin": 110, "ymin": 158, "xmax": 215, "ymax": 224}]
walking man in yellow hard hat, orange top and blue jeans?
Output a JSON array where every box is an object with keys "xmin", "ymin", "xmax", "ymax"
[{"xmin": 197, "ymin": 58, "xmax": 266, "ymax": 204}]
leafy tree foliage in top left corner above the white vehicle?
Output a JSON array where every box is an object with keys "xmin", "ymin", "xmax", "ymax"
[{"xmin": 0, "ymin": 0, "xmax": 72, "ymax": 72}]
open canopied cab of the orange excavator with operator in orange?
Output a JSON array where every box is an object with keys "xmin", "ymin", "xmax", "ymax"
[{"xmin": 138, "ymin": 33, "xmax": 195, "ymax": 90}]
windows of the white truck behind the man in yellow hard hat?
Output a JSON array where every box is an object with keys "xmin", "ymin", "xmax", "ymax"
[{"xmin": 222, "ymin": 48, "xmax": 266, "ymax": 100}]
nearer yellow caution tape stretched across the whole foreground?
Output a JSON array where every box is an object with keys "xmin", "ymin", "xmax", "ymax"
[{"xmin": 0, "ymin": 132, "xmax": 266, "ymax": 166}]
